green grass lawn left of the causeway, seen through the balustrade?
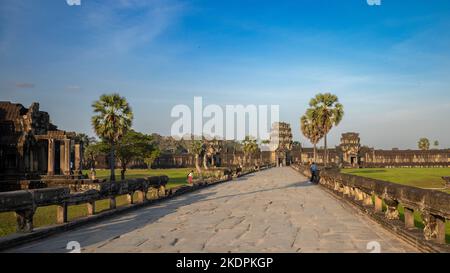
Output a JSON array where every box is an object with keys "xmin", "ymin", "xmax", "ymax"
[{"xmin": 0, "ymin": 168, "xmax": 191, "ymax": 236}]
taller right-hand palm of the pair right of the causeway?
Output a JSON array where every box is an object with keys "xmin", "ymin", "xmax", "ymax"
[{"xmin": 309, "ymin": 93, "xmax": 344, "ymax": 165}]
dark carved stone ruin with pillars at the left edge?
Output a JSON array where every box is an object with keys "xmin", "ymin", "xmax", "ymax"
[{"xmin": 0, "ymin": 102, "xmax": 88, "ymax": 191}]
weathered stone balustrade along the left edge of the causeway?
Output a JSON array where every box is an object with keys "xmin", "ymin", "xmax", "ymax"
[{"xmin": 0, "ymin": 165, "xmax": 272, "ymax": 236}]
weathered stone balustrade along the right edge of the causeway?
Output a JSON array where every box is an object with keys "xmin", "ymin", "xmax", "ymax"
[{"xmin": 293, "ymin": 165, "xmax": 450, "ymax": 249}]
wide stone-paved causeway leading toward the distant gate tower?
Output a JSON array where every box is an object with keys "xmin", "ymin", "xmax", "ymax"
[{"xmin": 10, "ymin": 167, "xmax": 417, "ymax": 252}]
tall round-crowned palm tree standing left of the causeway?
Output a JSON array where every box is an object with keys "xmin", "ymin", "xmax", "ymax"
[{"xmin": 92, "ymin": 94, "xmax": 133, "ymax": 181}]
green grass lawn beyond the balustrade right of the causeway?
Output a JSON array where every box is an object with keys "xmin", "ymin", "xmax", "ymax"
[{"xmin": 342, "ymin": 168, "xmax": 450, "ymax": 243}]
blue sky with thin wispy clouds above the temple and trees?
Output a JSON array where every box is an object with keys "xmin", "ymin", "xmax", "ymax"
[{"xmin": 0, "ymin": 0, "xmax": 450, "ymax": 148}]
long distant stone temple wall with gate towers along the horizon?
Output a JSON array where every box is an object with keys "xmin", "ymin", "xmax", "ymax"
[{"xmin": 155, "ymin": 132, "xmax": 450, "ymax": 168}]
